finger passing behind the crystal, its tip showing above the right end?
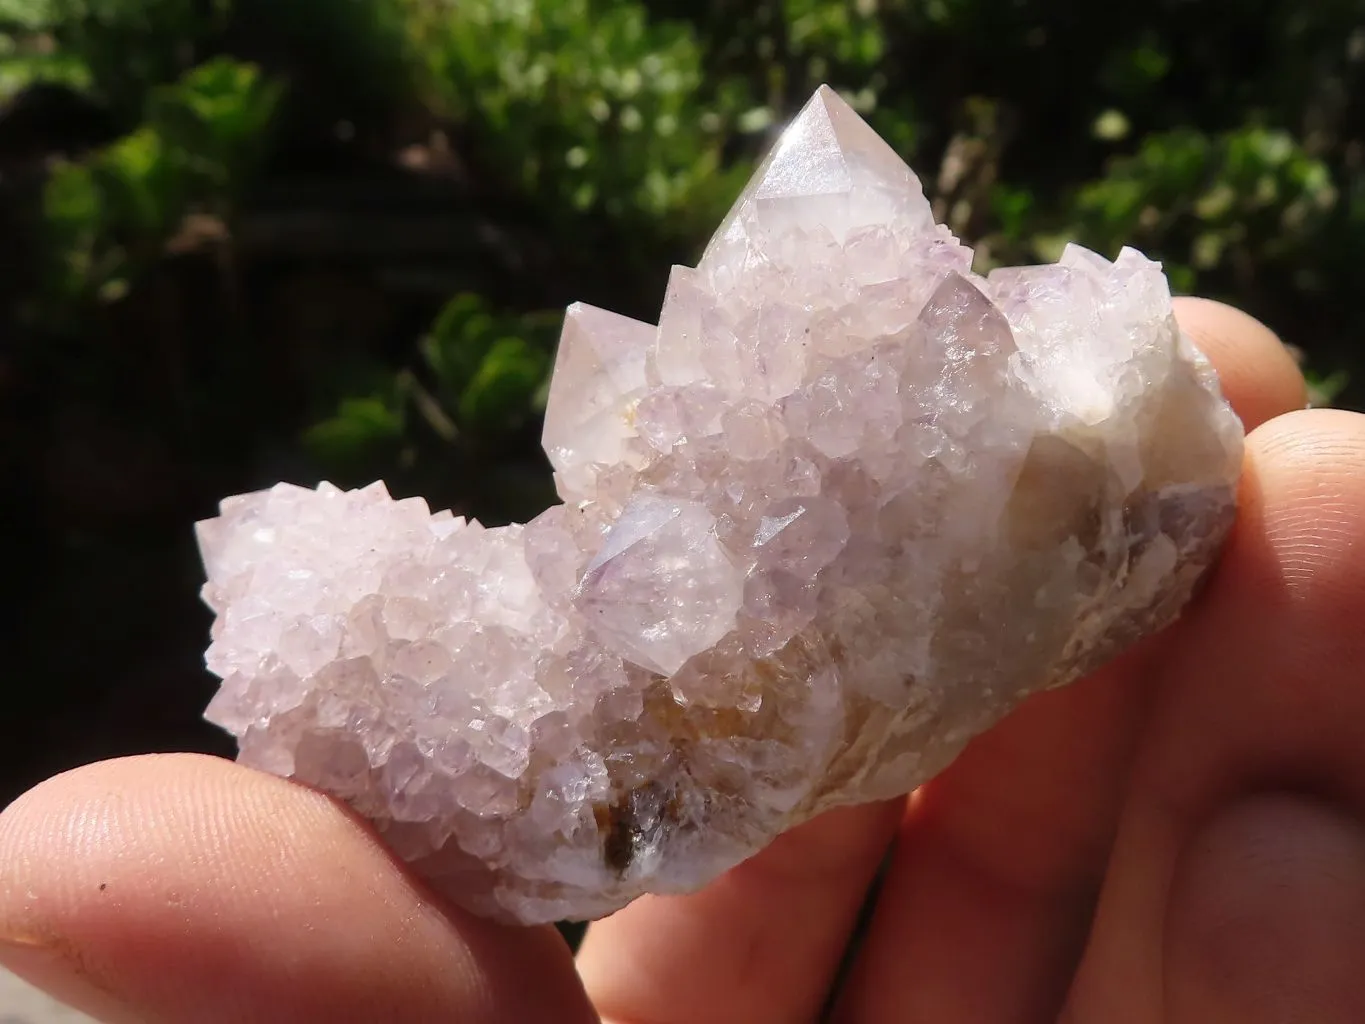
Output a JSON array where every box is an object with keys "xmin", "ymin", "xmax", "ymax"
[{"xmin": 824, "ymin": 299, "xmax": 1304, "ymax": 1024}]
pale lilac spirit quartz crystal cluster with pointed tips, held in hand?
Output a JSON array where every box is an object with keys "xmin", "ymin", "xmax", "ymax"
[{"xmin": 199, "ymin": 90, "xmax": 1242, "ymax": 922}]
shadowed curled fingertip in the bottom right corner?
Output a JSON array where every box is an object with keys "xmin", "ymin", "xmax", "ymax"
[{"xmin": 1163, "ymin": 795, "xmax": 1365, "ymax": 1024}]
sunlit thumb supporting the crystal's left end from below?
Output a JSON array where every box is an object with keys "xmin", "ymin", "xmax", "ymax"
[{"xmin": 0, "ymin": 755, "xmax": 594, "ymax": 1024}]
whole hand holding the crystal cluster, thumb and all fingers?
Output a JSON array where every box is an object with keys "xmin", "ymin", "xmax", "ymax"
[{"xmin": 0, "ymin": 292, "xmax": 1365, "ymax": 1024}]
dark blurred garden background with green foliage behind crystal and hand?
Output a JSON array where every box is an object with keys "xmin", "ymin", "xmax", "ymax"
[{"xmin": 0, "ymin": 0, "xmax": 1365, "ymax": 800}]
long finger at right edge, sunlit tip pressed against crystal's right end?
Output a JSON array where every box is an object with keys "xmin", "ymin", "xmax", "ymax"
[{"xmin": 1070, "ymin": 411, "xmax": 1365, "ymax": 1024}]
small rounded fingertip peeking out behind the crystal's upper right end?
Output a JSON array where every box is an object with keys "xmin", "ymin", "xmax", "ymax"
[{"xmin": 1174, "ymin": 298, "xmax": 1308, "ymax": 430}]
